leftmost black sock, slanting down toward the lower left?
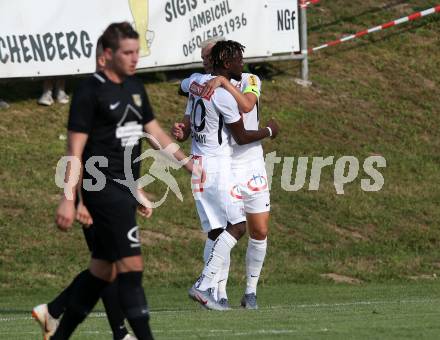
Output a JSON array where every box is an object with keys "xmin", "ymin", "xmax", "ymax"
[{"xmin": 50, "ymin": 270, "xmax": 108, "ymax": 340}]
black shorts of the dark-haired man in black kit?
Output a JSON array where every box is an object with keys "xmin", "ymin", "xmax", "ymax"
[{"xmin": 84, "ymin": 199, "xmax": 141, "ymax": 262}]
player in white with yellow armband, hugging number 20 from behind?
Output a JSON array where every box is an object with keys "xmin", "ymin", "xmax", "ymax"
[{"xmin": 203, "ymin": 73, "xmax": 270, "ymax": 309}]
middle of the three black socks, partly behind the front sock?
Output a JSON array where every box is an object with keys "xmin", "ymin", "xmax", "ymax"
[{"xmin": 101, "ymin": 279, "xmax": 128, "ymax": 340}]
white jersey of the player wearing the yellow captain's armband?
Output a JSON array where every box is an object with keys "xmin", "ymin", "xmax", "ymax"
[{"xmin": 231, "ymin": 73, "xmax": 263, "ymax": 166}]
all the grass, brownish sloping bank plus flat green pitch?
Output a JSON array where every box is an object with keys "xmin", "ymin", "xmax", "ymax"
[{"xmin": 0, "ymin": 0, "xmax": 440, "ymax": 340}]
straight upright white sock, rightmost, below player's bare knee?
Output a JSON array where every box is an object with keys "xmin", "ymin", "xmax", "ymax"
[{"xmin": 245, "ymin": 237, "xmax": 267, "ymax": 294}]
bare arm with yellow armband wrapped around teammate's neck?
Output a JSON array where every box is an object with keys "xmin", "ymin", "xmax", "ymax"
[{"xmin": 201, "ymin": 76, "xmax": 260, "ymax": 113}]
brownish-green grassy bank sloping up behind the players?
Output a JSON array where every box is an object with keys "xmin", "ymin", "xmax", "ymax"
[{"xmin": 0, "ymin": 0, "xmax": 440, "ymax": 306}]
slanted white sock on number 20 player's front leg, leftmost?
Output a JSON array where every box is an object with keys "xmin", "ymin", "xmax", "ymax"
[{"xmin": 195, "ymin": 230, "xmax": 237, "ymax": 290}]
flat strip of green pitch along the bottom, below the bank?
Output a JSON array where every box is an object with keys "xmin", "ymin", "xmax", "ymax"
[{"xmin": 0, "ymin": 283, "xmax": 440, "ymax": 340}]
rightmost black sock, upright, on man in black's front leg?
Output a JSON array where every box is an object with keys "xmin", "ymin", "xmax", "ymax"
[{"xmin": 118, "ymin": 272, "xmax": 153, "ymax": 340}]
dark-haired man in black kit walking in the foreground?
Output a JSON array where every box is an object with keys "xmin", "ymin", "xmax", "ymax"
[{"xmin": 43, "ymin": 22, "xmax": 192, "ymax": 340}]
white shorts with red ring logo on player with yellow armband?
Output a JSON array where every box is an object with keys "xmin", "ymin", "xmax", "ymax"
[{"xmin": 231, "ymin": 158, "xmax": 270, "ymax": 214}]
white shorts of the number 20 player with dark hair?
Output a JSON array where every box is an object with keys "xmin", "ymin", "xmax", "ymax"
[{"xmin": 191, "ymin": 160, "xmax": 246, "ymax": 233}]
